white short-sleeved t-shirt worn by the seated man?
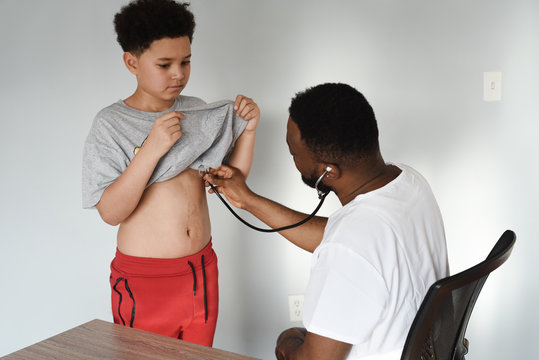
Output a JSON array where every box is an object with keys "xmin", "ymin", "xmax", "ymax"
[{"xmin": 303, "ymin": 165, "xmax": 449, "ymax": 360}]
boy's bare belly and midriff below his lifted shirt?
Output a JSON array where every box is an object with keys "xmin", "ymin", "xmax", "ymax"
[{"xmin": 118, "ymin": 169, "xmax": 211, "ymax": 258}]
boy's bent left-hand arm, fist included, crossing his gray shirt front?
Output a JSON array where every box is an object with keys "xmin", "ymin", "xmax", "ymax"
[{"xmin": 96, "ymin": 111, "xmax": 185, "ymax": 225}]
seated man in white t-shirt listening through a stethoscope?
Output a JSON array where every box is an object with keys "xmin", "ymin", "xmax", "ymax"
[{"xmin": 205, "ymin": 84, "xmax": 448, "ymax": 360}]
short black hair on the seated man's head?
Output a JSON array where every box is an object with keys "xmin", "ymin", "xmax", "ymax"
[{"xmin": 288, "ymin": 83, "xmax": 379, "ymax": 164}]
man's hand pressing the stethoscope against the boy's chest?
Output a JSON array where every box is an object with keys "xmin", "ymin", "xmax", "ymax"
[{"xmin": 204, "ymin": 165, "xmax": 253, "ymax": 209}]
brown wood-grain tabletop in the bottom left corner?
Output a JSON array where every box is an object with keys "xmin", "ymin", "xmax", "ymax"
[{"xmin": 2, "ymin": 320, "xmax": 255, "ymax": 360}]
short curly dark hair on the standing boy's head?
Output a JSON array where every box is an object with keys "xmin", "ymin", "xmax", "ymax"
[{"xmin": 114, "ymin": 0, "xmax": 195, "ymax": 56}]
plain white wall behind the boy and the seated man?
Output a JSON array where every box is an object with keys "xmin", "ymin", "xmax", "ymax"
[{"xmin": 0, "ymin": 0, "xmax": 539, "ymax": 360}]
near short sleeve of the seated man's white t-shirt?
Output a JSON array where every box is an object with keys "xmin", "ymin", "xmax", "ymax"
[{"xmin": 304, "ymin": 244, "xmax": 389, "ymax": 344}]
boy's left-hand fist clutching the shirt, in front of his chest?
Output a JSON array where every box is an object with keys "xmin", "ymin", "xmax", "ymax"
[{"xmin": 142, "ymin": 111, "xmax": 185, "ymax": 158}]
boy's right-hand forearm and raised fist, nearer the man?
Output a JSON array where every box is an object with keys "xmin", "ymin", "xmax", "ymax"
[{"xmin": 228, "ymin": 95, "xmax": 260, "ymax": 178}]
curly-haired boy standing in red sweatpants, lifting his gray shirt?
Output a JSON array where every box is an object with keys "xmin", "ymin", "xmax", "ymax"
[{"xmin": 83, "ymin": 0, "xmax": 260, "ymax": 346}]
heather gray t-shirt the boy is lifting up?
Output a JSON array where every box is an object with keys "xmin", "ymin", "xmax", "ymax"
[{"xmin": 82, "ymin": 95, "xmax": 247, "ymax": 208}]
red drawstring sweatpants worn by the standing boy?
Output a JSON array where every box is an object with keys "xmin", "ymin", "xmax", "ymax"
[{"xmin": 110, "ymin": 241, "xmax": 219, "ymax": 346}]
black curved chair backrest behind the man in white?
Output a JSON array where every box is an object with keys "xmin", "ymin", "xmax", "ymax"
[{"xmin": 401, "ymin": 230, "xmax": 516, "ymax": 360}]
